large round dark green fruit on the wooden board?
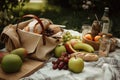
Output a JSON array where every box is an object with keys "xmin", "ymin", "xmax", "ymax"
[{"xmin": 1, "ymin": 54, "xmax": 23, "ymax": 73}]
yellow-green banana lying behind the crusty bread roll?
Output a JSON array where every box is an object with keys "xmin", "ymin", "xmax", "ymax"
[{"xmin": 72, "ymin": 42, "xmax": 94, "ymax": 53}]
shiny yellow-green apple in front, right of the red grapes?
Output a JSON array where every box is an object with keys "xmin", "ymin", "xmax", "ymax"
[{"xmin": 68, "ymin": 57, "xmax": 84, "ymax": 73}]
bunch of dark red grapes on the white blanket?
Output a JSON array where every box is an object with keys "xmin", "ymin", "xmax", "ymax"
[{"xmin": 52, "ymin": 53, "xmax": 70, "ymax": 70}]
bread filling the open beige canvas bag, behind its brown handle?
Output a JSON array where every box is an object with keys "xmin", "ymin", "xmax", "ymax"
[{"xmin": 23, "ymin": 18, "xmax": 62, "ymax": 36}]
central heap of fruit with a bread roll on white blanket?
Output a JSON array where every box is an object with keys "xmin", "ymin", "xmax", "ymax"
[{"xmin": 52, "ymin": 32, "xmax": 98, "ymax": 73}]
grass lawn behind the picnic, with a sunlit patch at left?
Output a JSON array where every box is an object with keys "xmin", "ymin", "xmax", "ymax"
[{"xmin": 13, "ymin": 3, "xmax": 120, "ymax": 37}]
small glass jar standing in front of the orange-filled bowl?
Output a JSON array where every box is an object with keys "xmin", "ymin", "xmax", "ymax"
[{"xmin": 98, "ymin": 37, "xmax": 111, "ymax": 57}]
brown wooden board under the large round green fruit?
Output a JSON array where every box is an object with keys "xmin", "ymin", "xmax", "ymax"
[{"xmin": 0, "ymin": 59, "xmax": 44, "ymax": 80}]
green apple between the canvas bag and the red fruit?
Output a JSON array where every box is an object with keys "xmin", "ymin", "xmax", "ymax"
[{"xmin": 54, "ymin": 45, "xmax": 66, "ymax": 58}]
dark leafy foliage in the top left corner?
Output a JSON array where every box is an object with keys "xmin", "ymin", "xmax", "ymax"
[{"xmin": 0, "ymin": 0, "xmax": 29, "ymax": 32}]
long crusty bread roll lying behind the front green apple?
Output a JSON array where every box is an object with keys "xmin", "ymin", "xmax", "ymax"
[{"xmin": 70, "ymin": 52, "xmax": 99, "ymax": 62}]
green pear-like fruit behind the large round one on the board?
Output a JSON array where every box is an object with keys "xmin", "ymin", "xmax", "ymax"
[{"xmin": 10, "ymin": 48, "xmax": 27, "ymax": 61}]
